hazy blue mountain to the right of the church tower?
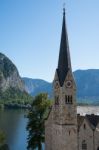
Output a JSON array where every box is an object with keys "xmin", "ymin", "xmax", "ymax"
[{"xmin": 74, "ymin": 69, "xmax": 99, "ymax": 104}]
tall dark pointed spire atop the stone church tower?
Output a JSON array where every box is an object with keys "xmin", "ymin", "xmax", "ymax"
[{"xmin": 57, "ymin": 8, "xmax": 71, "ymax": 86}]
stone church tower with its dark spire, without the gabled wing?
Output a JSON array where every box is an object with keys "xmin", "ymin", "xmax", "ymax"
[{"xmin": 45, "ymin": 9, "xmax": 77, "ymax": 150}]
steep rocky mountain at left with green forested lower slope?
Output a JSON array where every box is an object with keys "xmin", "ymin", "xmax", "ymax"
[{"xmin": 0, "ymin": 53, "xmax": 32, "ymax": 103}]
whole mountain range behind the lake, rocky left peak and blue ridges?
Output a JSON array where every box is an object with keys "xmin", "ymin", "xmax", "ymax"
[{"xmin": 0, "ymin": 53, "xmax": 99, "ymax": 105}]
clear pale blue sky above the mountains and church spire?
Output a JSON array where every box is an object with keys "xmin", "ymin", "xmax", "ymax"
[{"xmin": 0, "ymin": 0, "xmax": 99, "ymax": 82}]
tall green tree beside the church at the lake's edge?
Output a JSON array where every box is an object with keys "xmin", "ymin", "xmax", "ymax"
[{"xmin": 27, "ymin": 93, "xmax": 51, "ymax": 150}]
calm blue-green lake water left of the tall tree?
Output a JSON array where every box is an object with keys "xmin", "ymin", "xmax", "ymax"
[{"xmin": 0, "ymin": 109, "xmax": 28, "ymax": 150}]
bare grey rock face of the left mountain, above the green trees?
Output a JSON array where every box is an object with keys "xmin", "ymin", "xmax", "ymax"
[{"xmin": 0, "ymin": 53, "xmax": 25, "ymax": 92}]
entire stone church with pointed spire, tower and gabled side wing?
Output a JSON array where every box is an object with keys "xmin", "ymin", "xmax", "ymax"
[{"xmin": 45, "ymin": 9, "xmax": 99, "ymax": 150}]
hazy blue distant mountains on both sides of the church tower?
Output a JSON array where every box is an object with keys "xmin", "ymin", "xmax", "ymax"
[{"xmin": 23, "ymin": 69, "xmax": 99, "ymax": 105}]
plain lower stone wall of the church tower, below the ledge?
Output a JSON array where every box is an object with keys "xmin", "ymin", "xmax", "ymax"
[{"xmin": 52, "ymin": 124, "xmax": 77, "ymax": 150}]
